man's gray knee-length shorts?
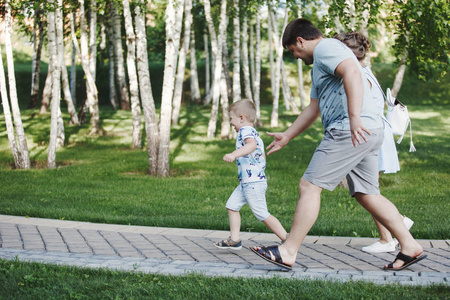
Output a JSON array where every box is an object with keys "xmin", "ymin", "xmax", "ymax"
[{"xmin": 303, "ymin": 128, "xmax": 383, "ymax": 196}]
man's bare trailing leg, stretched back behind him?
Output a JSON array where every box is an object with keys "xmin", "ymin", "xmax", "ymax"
[{"xmin": 355, "ymin": 193, "xmax": 423, "ymax": 268}]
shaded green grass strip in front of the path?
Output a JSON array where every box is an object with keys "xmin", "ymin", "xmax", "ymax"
[{"xmin": 0, "ymin": 260, "xmax": 448, "ymax": 299}]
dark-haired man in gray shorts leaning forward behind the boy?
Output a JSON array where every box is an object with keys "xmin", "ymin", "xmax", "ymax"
[{"xmin": 251, "ymin": 19, "xmax": 426, "ymax": 271}]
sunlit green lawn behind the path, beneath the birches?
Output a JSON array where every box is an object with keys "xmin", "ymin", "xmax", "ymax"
[{"xmin": 0, "ymin": 101, "xmax": 450, "ymax": 239}]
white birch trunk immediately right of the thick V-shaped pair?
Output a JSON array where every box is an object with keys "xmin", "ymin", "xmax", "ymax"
[{"xmin": 172, "ymin": 0, "xmax": 192, "ymax": 125}]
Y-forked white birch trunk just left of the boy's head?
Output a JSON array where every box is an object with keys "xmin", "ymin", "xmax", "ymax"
[{"xmin": 204, "ymin": 0, "xmax": 227, "ymax": 138}]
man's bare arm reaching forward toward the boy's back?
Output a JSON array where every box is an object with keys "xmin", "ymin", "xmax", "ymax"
[{"xmin": 266, "ymin": 98, "xmax": 320, "ymax": 155}]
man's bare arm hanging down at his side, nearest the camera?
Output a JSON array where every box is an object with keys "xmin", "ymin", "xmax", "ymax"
[{"xmin": 334, "ymin": 58, "xmax": 370, "ymax": 147}]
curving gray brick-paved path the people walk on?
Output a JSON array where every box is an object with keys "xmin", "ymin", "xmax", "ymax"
[{"xmin": 0, "ymin": 215, "xmax": 450, "ymax": 285}]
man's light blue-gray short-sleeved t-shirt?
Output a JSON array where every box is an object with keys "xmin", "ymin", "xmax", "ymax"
[{"xmin": 311, "ymin": 39, "xmax": 383, "ymax": 130}]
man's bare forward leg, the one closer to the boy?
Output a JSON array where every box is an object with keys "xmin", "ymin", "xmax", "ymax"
[{"xmin": 254, "ymin": 178, "xmax": 322, "ymax": 265}]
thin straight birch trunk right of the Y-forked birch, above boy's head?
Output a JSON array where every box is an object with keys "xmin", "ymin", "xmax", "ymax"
[{"xmin": 233, "ymin": 0, "xmax": 241, "ymax": 102}]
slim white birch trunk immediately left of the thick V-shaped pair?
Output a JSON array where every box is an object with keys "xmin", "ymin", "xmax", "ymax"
[{"xmin": 123, "ymin": 0, "xmax": 142, "ymax": 149}]
